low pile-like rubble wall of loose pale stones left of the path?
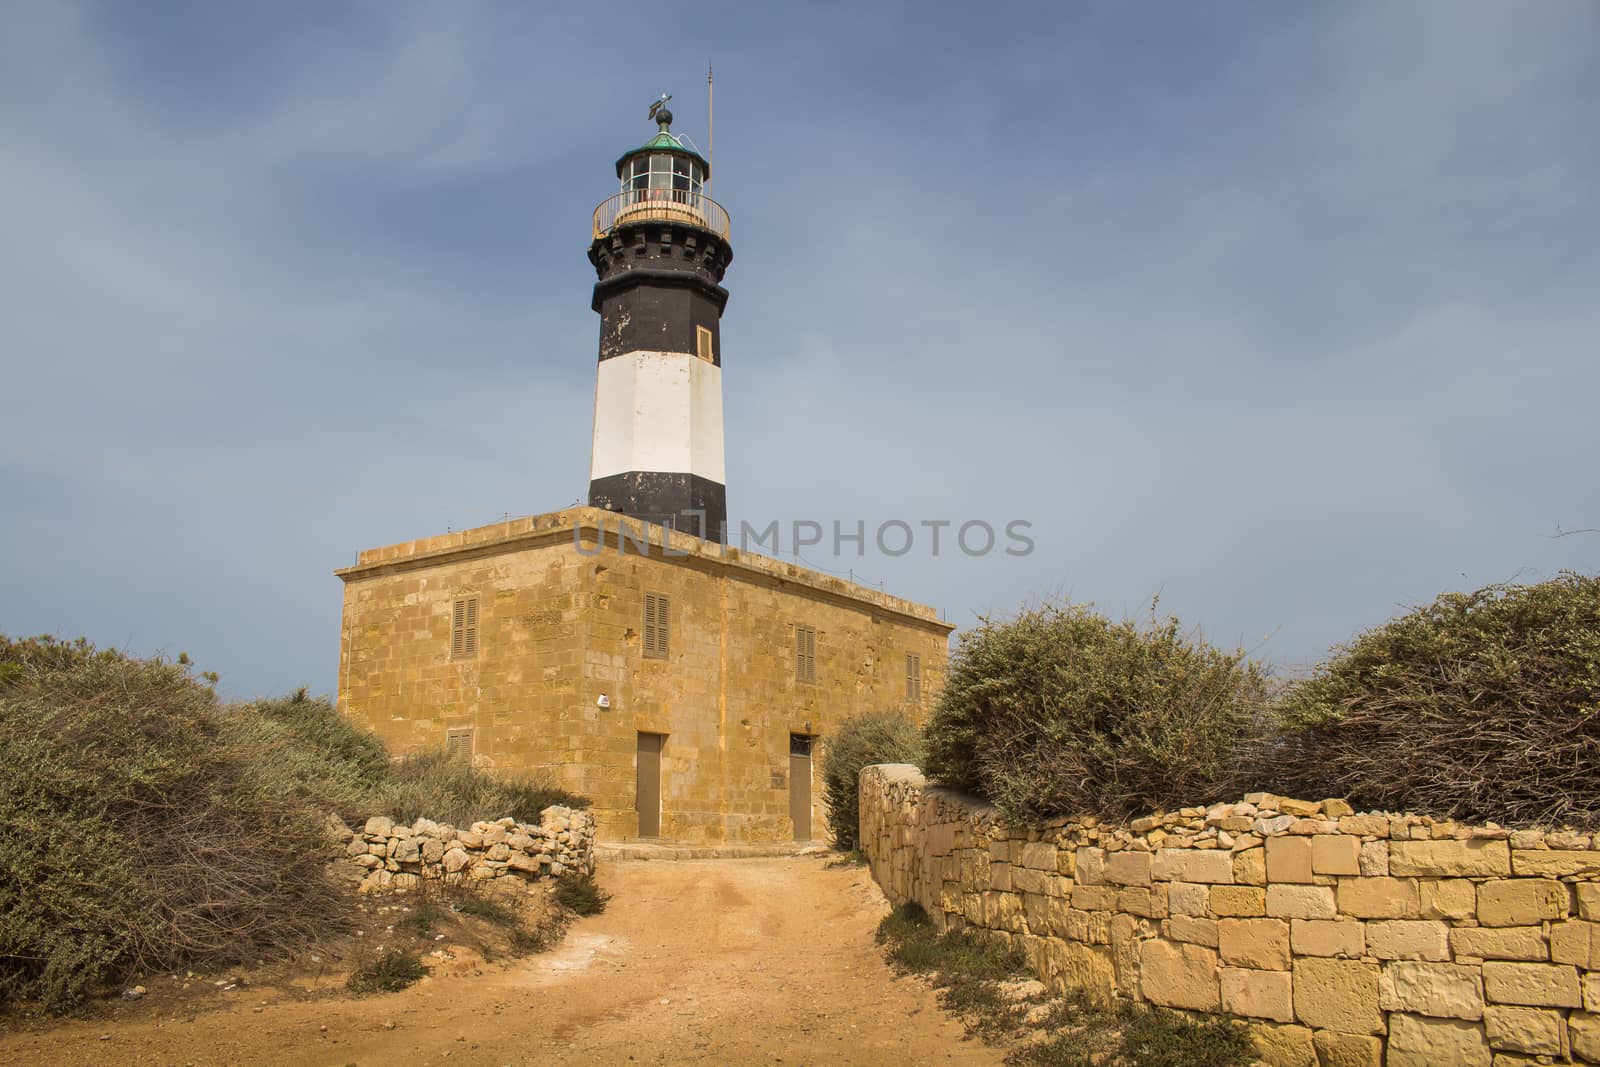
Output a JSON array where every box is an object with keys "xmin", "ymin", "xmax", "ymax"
[{"xmin": 344, "ymin": 806, "xmax": 595, "ymax": 893}]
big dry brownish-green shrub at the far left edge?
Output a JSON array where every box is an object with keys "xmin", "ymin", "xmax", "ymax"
[{"xmin": 0, "ymin": 637, "xmax": 346, "ymax": 1011}]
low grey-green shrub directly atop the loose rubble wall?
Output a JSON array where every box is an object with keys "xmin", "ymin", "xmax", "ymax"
[{"xmin": 373, "ymin": 750, "xmax": 589, "ymax": 825}]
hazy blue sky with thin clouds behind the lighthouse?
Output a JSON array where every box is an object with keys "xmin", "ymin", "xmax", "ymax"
[{"xmin": 0, "ymin": 0, "xmax": 1600, "ymax": 697}]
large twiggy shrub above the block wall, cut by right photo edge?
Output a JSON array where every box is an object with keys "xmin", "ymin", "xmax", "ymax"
[{"xmin": 1262, "ymin": 574, "xmax": 1600, "ymax": 829}]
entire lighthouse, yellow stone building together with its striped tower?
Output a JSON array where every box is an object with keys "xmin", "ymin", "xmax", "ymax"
[{"xmin": 338, "ymin": 106, "xmax": 954, "ymax": 841}]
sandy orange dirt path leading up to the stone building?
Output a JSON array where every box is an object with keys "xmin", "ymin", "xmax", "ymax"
[{"xmin": 0, "ymin": 857, "xmax": 1000, "ymax": 1067}]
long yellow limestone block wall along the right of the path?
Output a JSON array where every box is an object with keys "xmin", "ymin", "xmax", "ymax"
[{"xmin": 861, "ymin": 765, "xmax": 1600, "ymax": 1067}]
